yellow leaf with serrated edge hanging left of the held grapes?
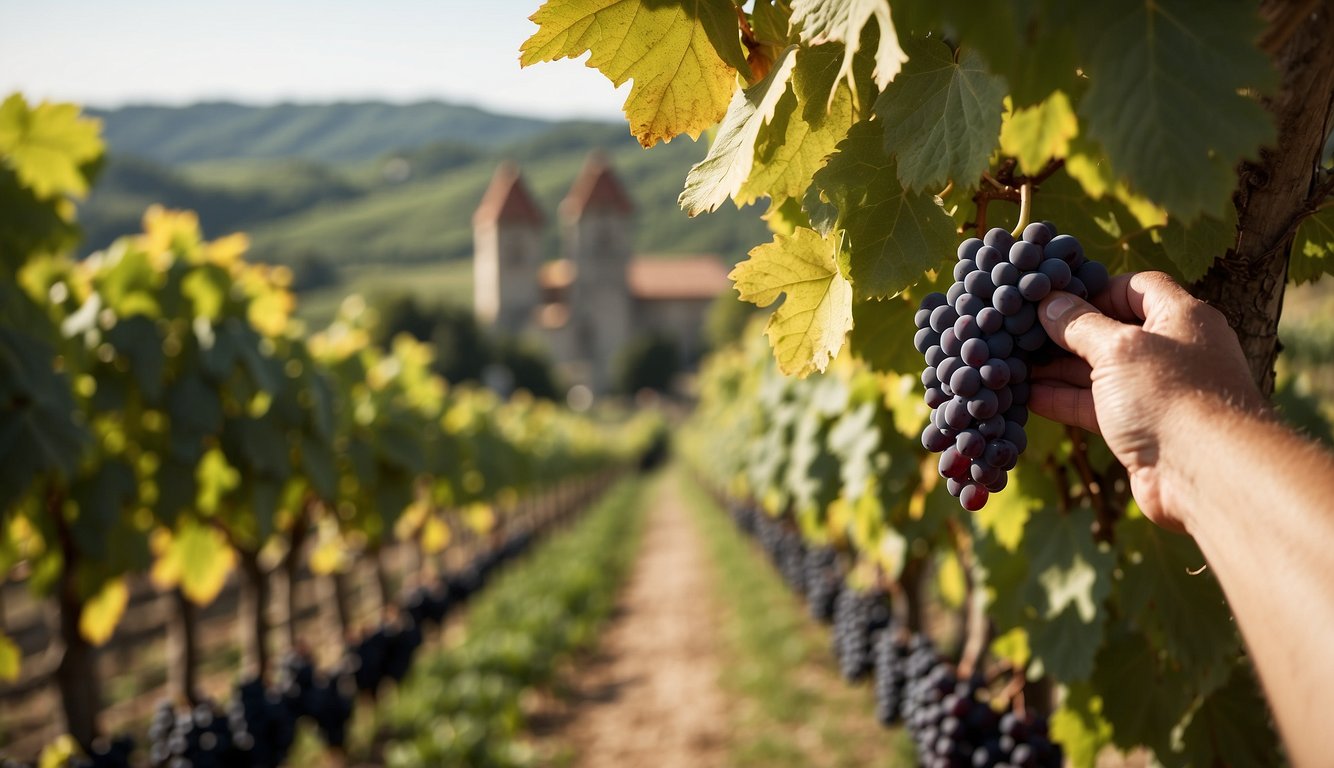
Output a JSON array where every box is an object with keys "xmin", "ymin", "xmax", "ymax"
[{"xmin": 730, "ymin": 228, "xmax": 852, "ymax": 376}]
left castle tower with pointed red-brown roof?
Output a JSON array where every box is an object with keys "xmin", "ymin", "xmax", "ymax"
[{"xmin": 472, "ymin": 161, "xmax": 543, "ymax": 335}]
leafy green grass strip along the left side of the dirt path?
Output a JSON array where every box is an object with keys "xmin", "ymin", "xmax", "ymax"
[{"xmin": 380, "ymin": 479, "xmax": 644, "ymax": 768}]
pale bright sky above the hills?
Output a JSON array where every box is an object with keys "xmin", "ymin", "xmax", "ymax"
[{"xmin": 0, "ymin": 0, "xmax": 630, "ymax": 119}]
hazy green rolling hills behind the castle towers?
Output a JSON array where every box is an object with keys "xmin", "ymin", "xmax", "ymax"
[{"xmin": 80, "ymin": 103, "xmax": 768, "ymax": 277}]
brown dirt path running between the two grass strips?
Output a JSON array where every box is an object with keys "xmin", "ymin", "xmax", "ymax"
[{"xmin": 543, "ymin": 477, "xmax": 728, "ymax": 768}]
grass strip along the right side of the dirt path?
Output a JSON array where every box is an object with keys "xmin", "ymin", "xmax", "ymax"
[{"xmin": 675, "ymin": 469, "xmax": 916, "ymax": 768}]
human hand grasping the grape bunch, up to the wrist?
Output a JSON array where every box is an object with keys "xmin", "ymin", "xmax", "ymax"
[{"xmin": 1029, "ymin": 272, "xmax": 1265, "ymax": 531}]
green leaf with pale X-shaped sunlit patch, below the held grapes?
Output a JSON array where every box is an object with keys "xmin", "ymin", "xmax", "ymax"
[{"xmin": 1021, "ymin": 509, "xmax": 1115, "ymax": 683}]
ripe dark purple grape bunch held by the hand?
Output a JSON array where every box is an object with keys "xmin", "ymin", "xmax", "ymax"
[{"xmin": 914, "ymin": 221, "xmax": 1107, "ymax": 511}]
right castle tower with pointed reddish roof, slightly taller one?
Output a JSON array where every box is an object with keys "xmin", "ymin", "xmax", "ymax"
[{"xmin": 560, "ymin": 152, "xmax": 635, "ymax": 393}]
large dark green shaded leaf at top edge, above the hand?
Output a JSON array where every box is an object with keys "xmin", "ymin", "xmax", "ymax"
[{"xmin": 1079, "ymin": 0, "xmax": 1275, "ymax": 223}]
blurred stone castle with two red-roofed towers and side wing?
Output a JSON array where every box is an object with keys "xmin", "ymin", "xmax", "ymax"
[{"xmin": 472, "ymin": 153, "xmax": 731, "ymax": 395}]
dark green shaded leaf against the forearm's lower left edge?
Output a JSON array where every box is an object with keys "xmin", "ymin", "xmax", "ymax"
[{"xmin": 1117, "ymin": 515, "xmax": 1238, "ymax": 676}]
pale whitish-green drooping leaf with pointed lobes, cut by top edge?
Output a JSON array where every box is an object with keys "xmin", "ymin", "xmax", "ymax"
[{"xmin": 792, "ymin": 0, "xmax": 908, "ymax": 99}]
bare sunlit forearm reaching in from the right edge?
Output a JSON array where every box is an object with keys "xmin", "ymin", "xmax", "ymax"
[{"xmin": 1161, "ymin": 403, "xmax": 1334, "ymax": 765}]
